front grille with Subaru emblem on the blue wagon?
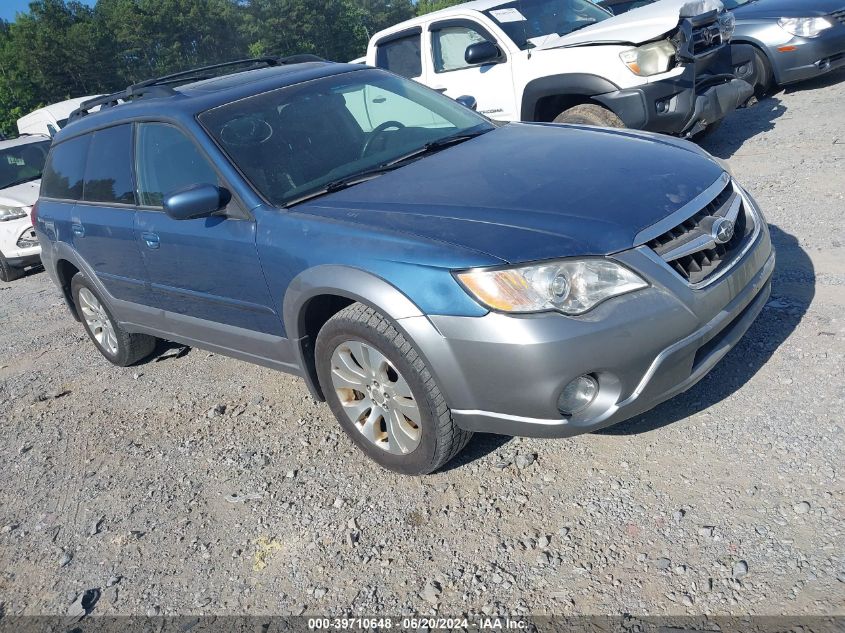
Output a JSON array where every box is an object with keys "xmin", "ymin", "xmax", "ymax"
[{"xmin": 647, "ymin": 182, "xmax": 755, "ymax": 285}]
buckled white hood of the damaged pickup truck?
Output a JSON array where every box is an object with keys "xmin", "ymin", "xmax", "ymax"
[{"xmin": 538, "ymin": 0, "xmax": 724, "ymax": 50}]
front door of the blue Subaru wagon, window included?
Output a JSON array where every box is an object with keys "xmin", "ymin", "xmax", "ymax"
[{"xmin": 130, "ymin": 122, "xmax": 282, "ymax": 338}]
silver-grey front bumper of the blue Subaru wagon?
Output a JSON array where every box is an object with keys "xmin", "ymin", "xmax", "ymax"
[{"xmin": 402, "ymin": 202, "xmax": 775, "ymax": 437}]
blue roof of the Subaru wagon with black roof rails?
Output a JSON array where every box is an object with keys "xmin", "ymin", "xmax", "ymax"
[{"xmin": 54, "ymin": 62, "xmax": 364, "ymax": 142}]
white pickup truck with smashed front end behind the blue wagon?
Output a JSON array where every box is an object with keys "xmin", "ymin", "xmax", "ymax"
[{"xmin": 366, "ymin": 0, "xmax": 754, "ymax": 137}]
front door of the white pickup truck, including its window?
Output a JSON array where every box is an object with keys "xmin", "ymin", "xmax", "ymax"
[{"xmin": 424, "ymin": 18, "xmax": 519, "ymax": 121}]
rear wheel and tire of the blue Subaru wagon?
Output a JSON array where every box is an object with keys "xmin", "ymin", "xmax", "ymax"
[{"xmin": 70, "ymin": 273, "xmax": 158, "ymax": 367}]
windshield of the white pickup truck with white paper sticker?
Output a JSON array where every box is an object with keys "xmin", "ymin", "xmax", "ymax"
[{"xmin": 484, "ymin": 0, "xmax": 612, "ymax": 50}]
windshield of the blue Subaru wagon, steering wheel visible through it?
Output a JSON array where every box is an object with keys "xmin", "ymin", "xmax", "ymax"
[{"xmin": 200, "ymin": 70, "xmax": 493, "ymax": 207}]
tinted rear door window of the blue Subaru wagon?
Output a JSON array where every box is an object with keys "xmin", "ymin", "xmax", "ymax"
[{"xmin": 82, "ymin": 125, "xmax": 135, "ymax": 204}]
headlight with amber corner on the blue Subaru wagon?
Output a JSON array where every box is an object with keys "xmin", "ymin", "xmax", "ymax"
[{"xmin": 455, "ymin": 258, "xmax": 648, "ymax": 315}]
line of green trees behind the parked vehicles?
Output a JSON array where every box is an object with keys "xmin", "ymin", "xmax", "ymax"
[{"xmin": 0, "ymin": 0, "xmax": 461, "ymax": 135}]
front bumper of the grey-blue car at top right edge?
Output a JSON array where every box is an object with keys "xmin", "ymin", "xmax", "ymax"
[{"xmin": 768, "ymin": 24, "xmax": 845, "ymax": 84}]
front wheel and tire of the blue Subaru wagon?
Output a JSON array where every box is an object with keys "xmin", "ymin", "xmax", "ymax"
[{"xmin": 315, "ymin": 303, "xmax": 472, "ymax": 475}]
